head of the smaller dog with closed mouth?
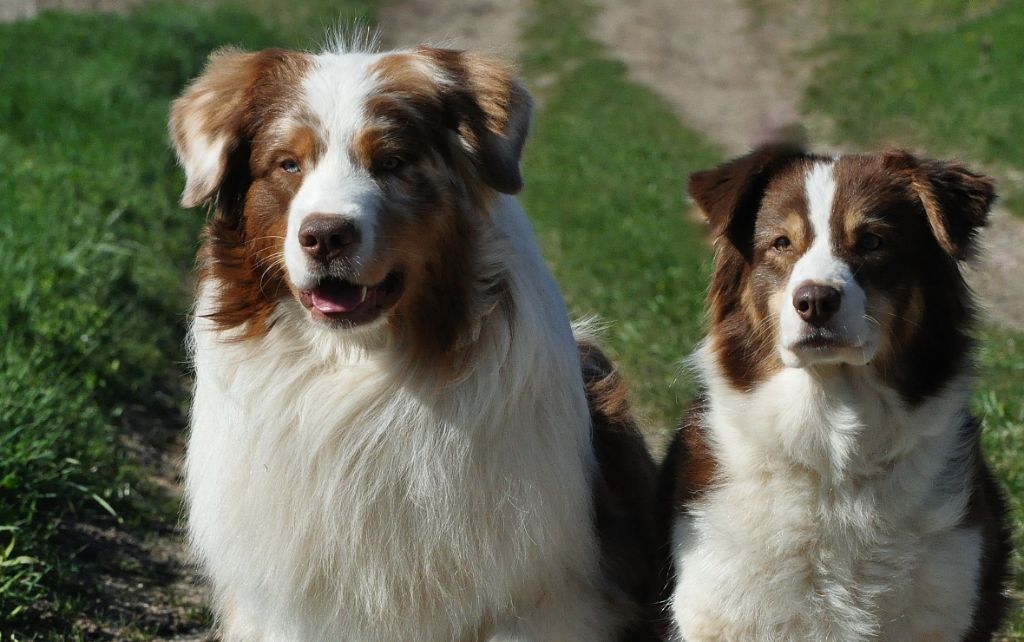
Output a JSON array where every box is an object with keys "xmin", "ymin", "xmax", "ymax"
[{"xmin": 689, "ymin": 144, "xmax": 994, "ymax": 398}]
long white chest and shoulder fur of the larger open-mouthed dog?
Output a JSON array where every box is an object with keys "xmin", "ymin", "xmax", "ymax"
[{"xmin": 185, "ymin": 48, "xmax": 611, "ymax": 642}]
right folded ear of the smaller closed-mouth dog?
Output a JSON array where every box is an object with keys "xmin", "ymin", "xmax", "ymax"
[{"xmin": 883, "ymin": 149, "xmax": 995, "ymax": 260}]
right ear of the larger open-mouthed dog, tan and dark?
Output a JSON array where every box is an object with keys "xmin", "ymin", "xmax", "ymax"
[{"xmin": 417, "ymin": 47, "xmax": 534, "ymax": 194}]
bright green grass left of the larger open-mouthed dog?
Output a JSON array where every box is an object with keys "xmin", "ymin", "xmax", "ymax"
[{"xmin": 0, "ymin": 2, "xmax": 370, "ymax": 639}]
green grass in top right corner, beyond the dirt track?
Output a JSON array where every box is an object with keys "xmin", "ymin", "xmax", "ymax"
[{"xmin": 805, "ymin": 0, "xmax": 1024, "ymax": 213}]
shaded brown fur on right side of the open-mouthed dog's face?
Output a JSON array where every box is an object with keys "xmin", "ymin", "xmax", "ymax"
[{"xmin": 354, "ymin": 49, "xmax": 524, "ymax": 371}]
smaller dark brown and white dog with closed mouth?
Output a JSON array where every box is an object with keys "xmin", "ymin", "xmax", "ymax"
[{"xmin": 659, "ymin": 143, "xmax": 1010, "ymax": 642}]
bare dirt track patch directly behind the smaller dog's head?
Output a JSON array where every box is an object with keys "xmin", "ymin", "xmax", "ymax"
[{"xmin": 594, "ymin": 0, "xmax": 823, "ymax": 154}]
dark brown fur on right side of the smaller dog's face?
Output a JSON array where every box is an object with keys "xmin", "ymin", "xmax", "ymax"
[{"xmin": 833, "ymin": 153, "xmax": 978, "ymax": 405}]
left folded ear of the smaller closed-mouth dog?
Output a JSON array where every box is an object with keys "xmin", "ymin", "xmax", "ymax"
[{"xmin": 689, "ymin": 142, "xmax": 805, "ymax": 260}]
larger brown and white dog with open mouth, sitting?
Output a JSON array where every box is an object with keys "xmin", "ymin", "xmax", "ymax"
[{"xmin": 171, "ymin": 42, "xmax": 656, "ymax": 642}]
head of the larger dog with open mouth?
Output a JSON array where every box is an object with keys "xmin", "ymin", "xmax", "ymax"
[{"xmin": 170, "ymin": 47, "xmax": 530, "ymax": 354}]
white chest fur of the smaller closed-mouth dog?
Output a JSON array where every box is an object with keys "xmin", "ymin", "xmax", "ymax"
[{"xmin": 671, "ymin": 160, "xmax": 981, "ymax": 642}]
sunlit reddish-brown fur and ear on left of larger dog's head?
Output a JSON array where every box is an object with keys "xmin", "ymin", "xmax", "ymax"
[{"xmin": 184, "ymin": 49, "xmax": 321, "ymax": 340}]
